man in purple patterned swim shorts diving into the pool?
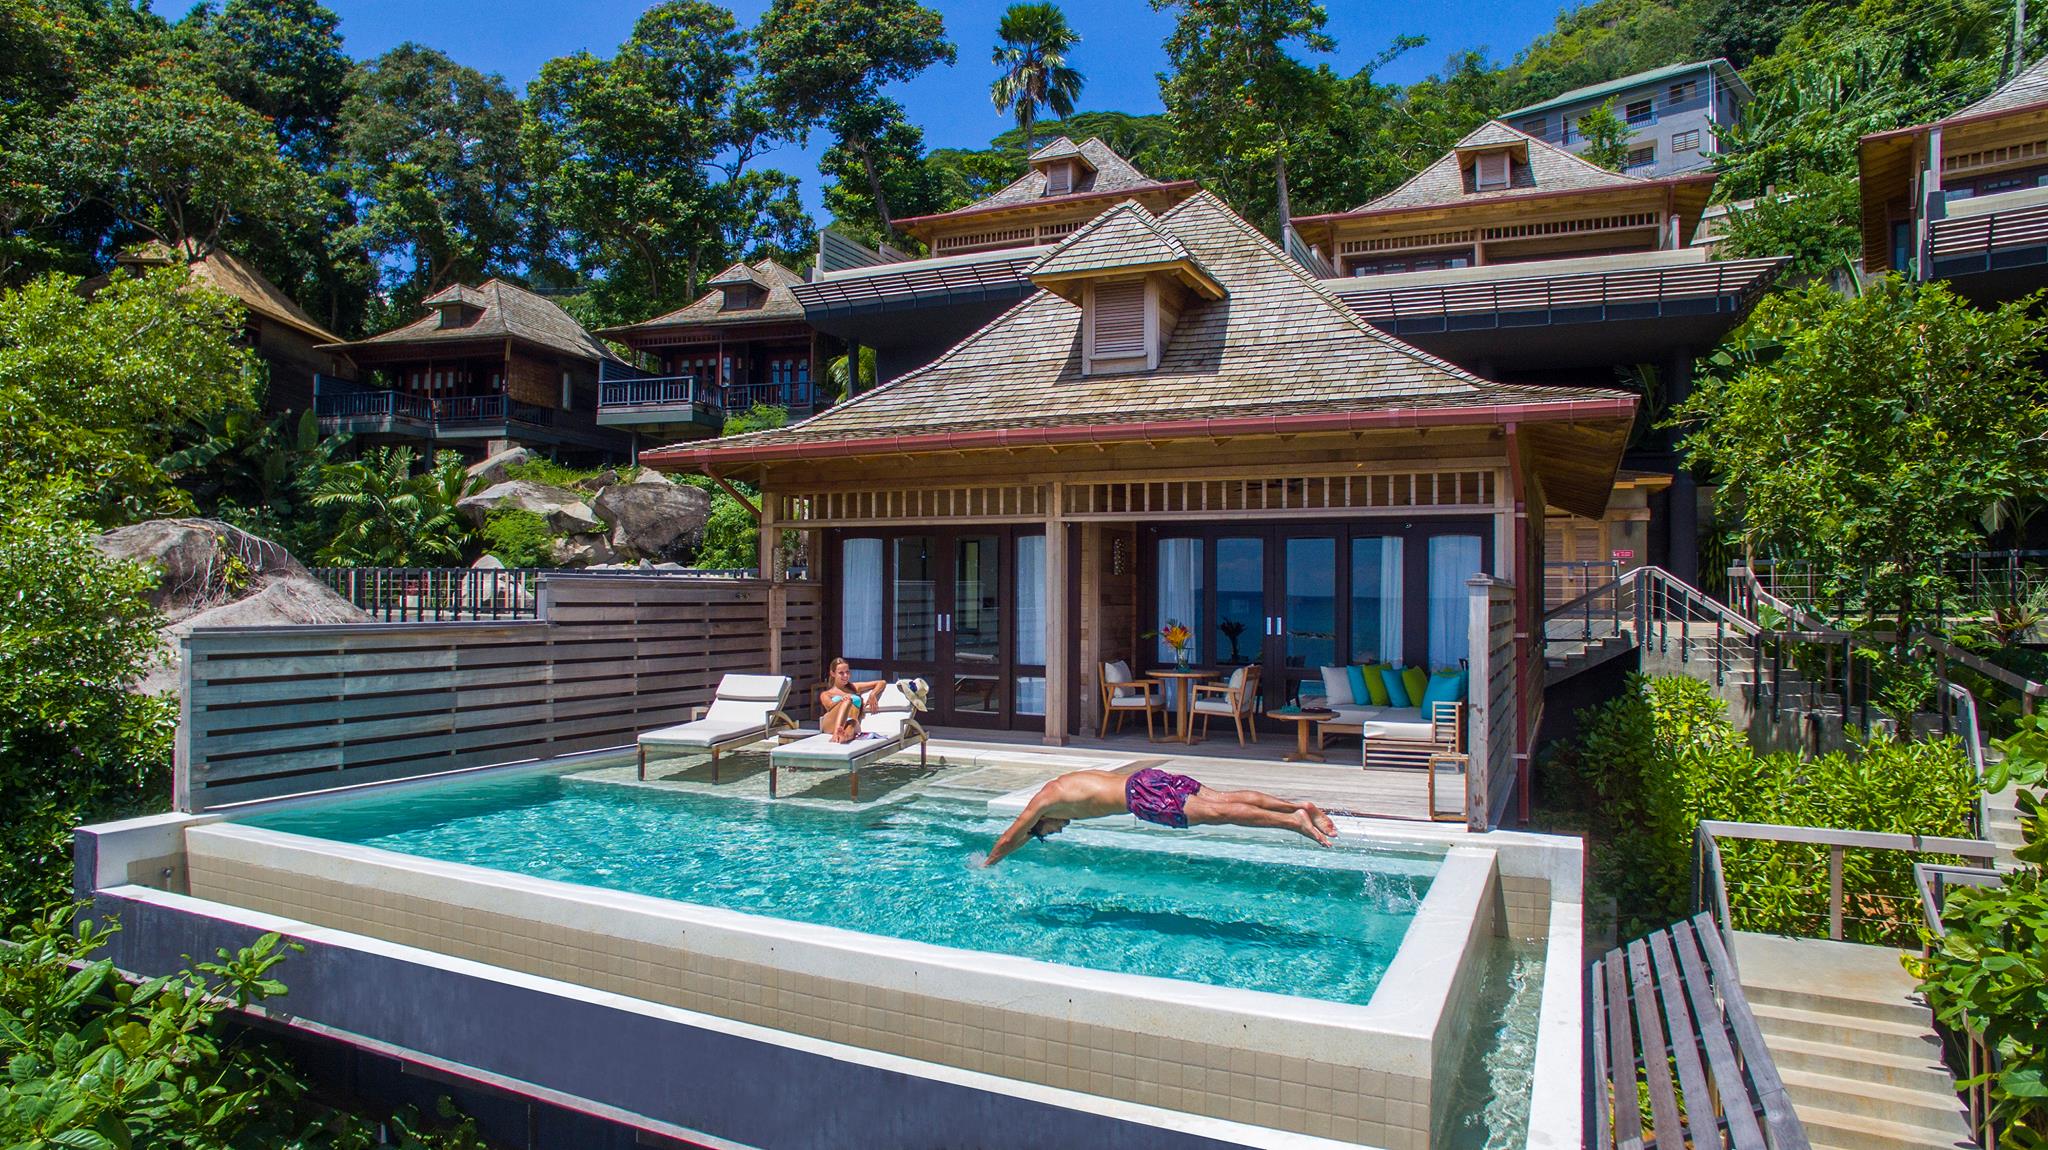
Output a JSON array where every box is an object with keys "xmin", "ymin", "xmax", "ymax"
[{"xmin": 981, "ymin": 767, "xmax": 1337, "ymax": 866}]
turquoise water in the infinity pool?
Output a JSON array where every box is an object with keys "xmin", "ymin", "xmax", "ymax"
[{"xmin": 244, "ymin": 771, "xmax": 1442, "ymax": 1003}]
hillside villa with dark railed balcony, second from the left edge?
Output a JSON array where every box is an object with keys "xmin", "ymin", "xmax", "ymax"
[{"xmin": 313, "ymin": 278, "xmax": 629, "ymax": 458}]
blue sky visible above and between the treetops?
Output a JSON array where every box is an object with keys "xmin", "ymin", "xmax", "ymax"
[{"xmin": 328, "ymin": 0, "xmax": 1559, "ymax": 217}]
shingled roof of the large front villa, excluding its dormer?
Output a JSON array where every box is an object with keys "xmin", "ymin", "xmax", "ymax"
[{"xmin": 655, "ymin": 192, "xmax": 1632, "ymax": 458}]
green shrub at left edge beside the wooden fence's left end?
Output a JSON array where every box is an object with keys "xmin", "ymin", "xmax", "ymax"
[{"xmin": 0, "ymin": 477, "xmax": 178, "ymax": 919}]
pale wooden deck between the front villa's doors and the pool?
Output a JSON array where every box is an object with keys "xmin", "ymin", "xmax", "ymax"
[{"xmin": 590, "ymin": 728, "xmax": 1464, "ymax": 829}]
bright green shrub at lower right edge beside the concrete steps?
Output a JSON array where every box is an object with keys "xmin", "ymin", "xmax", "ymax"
[{"xmin": 1907, "ymin": 714, "xmax": 2048, "ymax": 1150}]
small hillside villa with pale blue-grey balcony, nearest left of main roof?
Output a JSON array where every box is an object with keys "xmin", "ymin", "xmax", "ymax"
[{"xmin": 598, "ymin": 260, "xmax": 827, "ymax": 446}]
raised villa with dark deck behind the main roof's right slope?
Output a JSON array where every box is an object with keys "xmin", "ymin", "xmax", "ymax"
[{"xmin": 1292, "ymin": 121, "xmax": 1786, "ymax": 579}]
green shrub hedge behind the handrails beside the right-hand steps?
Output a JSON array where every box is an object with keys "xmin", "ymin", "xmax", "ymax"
[{"xmin": 1569, "ymin": 675, "xmax": 1976, "ymax": 943}]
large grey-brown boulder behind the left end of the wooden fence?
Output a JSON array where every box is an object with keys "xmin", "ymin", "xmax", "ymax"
[{"xmin": 94, "ymin": 520, "xmax": 371, "ymax": 694}]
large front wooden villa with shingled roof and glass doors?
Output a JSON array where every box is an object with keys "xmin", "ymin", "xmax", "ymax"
[{"xmin": 641, "ymin": 192, "xmax": 1636, "ymax": 822}]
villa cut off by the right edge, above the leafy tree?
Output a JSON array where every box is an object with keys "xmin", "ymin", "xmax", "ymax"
[{"xmin": 1858, "ymin": 57, "xmax": 2048, "ymax": 303}]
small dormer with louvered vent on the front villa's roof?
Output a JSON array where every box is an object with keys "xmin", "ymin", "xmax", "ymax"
[{"xmin": 1028, "ymin": 201, "xmax": 1223, "ymax": 374}]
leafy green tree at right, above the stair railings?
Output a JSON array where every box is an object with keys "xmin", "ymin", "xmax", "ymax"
[{"xmin": 1677, "ymin": 278, "xmax": 2048, "ymax": 634}]
